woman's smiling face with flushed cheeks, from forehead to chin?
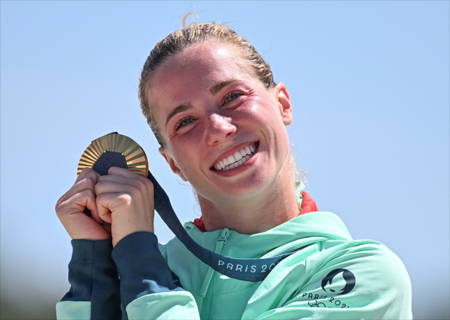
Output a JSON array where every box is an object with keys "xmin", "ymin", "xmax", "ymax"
[{"xmin": 148, "ymin": 42, "xmax": 292, "ymax": 203}]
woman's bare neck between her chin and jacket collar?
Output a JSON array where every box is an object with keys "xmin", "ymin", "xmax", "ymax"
[{"xmin": 199, "ymin": 169, "xmax": 299, "ymax": 234}]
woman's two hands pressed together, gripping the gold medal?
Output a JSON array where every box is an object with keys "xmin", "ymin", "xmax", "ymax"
[{"xmin": 55, "ymin": 167, "xmax": 154, "ymax": 245}]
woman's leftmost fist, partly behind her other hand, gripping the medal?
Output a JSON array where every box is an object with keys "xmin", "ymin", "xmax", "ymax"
[{"xmin": 55, "ymin": 168, "xmax": 111, "ymax": 240}]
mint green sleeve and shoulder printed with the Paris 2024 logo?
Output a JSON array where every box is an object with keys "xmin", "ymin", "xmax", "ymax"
[{"xmin": 242, "ymin": 241, "xmax": 412, "ymax": 319}]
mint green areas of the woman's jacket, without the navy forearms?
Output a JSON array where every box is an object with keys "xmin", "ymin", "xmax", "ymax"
[{"xmin": 57, "ymin": 212, "xmax": 412, "ymax": 320}]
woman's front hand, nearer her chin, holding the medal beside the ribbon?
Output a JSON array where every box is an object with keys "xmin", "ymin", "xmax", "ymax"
[{"xmin": 95, "ymin": 167, "xmax": 154, "ymax": 246}]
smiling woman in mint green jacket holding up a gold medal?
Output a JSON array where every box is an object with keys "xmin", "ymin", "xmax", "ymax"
[{"xmin": 56, "ymin": 23, "xmax": 412, "ymax": 319}]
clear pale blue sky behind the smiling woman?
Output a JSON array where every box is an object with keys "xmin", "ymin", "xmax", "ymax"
[{"xmin": 0, "ymin": 1, "xmax": 449, "ymax": 319}]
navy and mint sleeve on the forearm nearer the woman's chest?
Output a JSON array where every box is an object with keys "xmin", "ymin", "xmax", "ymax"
[{"xmin": 112, "ymin": 232, "xmax": 200, "ymax": 320}]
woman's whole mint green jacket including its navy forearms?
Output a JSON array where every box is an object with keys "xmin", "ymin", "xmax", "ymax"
[{"xmin": 57, "ymin": 194, "xmax": 412, "ymax": 319}]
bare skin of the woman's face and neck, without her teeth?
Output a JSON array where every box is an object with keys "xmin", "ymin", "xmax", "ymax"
[{"xmin": 148, "ymin": 42, "xmax": 298, "ymax": 233}]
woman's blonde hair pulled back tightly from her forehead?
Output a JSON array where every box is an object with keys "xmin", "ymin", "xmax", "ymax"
[{"xmin": 139, "ymin": 13, "xmax": 275, "ymax": 147}]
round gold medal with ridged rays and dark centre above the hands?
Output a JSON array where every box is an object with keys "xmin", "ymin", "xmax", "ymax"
[{"xmin": 77, "ymin": 132, "xmax": 148, "ymax": 177}]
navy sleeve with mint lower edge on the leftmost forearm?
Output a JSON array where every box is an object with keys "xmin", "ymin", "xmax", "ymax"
[{"xmin": 56, "ymin": 240, "xmax": 122, "ymax": 320}]
